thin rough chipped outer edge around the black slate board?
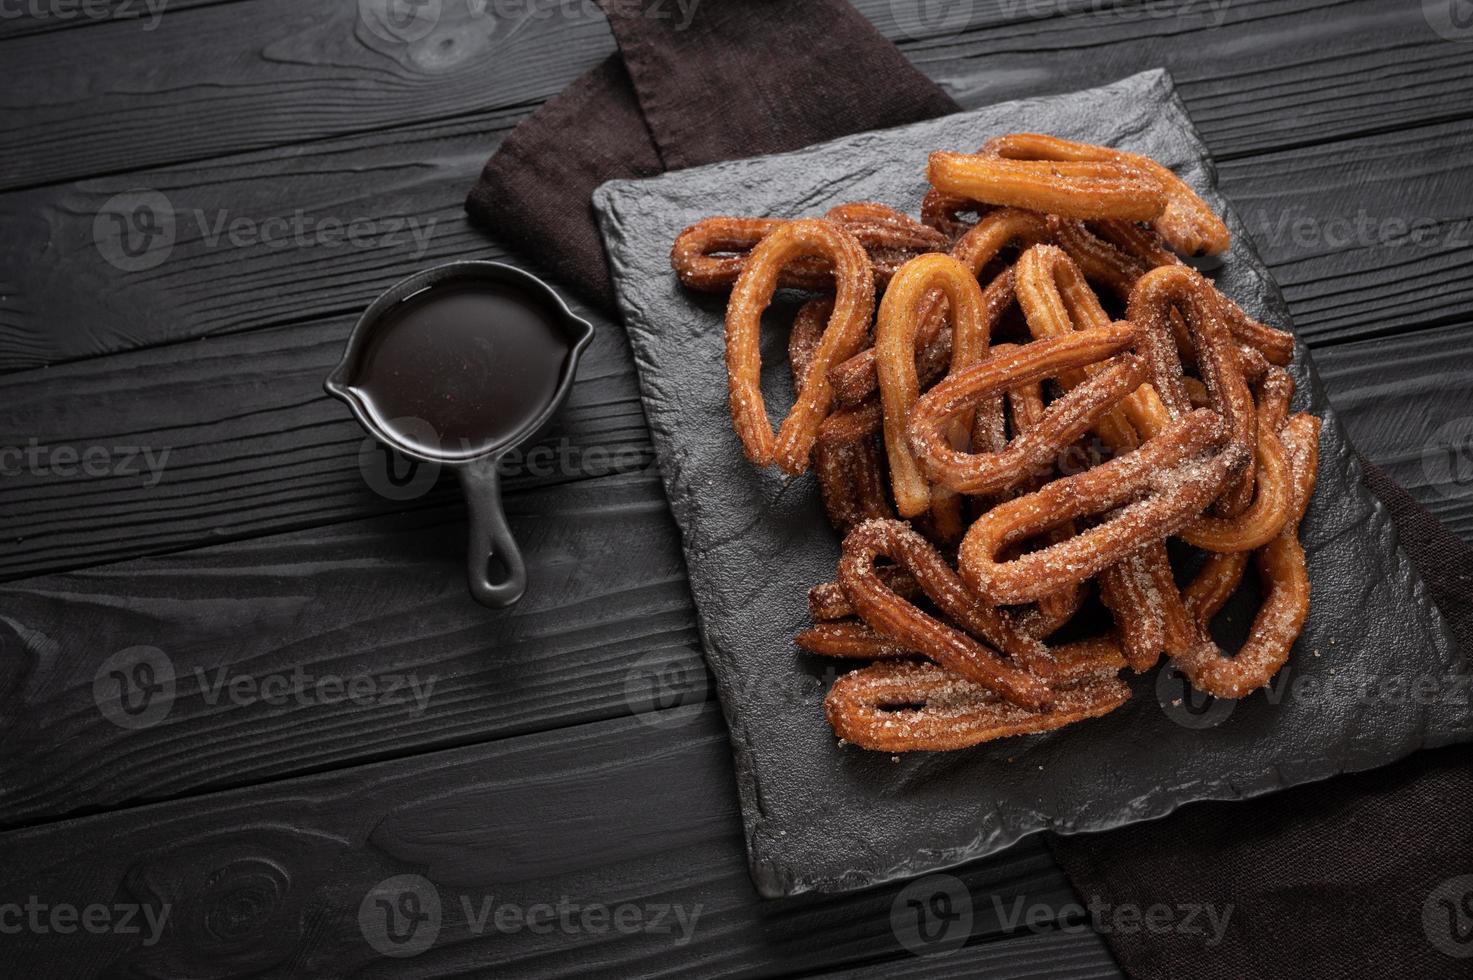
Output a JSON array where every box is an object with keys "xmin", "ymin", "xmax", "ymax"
[{"xmin": 592, "ymin": 68, "xmax": 1473, "ymax": 897}]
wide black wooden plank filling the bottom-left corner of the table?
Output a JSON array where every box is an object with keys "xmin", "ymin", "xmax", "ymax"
[{"xmin": 0, "ymin": 707, "xmax": 1100, "ymax": 979}]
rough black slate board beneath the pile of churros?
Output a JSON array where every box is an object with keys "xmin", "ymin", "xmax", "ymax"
[{"xmin": 594, "ymin": 71, "xmax": 1473, "ymax": 896}]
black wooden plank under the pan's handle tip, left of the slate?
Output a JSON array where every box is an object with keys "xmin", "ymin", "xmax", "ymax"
[{"xmin": 0, "ymin": 476, "xmax": 709, "ymax": 827}]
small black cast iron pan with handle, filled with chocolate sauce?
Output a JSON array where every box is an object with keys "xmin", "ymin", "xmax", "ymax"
[{"xmin": 326, "ymin": 262, "xmax": 594, "ymax": 609}]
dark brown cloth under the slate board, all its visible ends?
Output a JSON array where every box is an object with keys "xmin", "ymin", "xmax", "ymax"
[{"xmin": 467, "ymin": 0, "xmax": 1473, "ymax": 980}]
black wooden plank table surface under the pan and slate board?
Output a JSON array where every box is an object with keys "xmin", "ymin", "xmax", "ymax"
[{"xmin": 0, "ymin": 0, "xmax": 1473, "ymax": 977}]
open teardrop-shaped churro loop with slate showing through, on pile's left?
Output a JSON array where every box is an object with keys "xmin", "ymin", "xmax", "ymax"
[{"xmin": 726, "ymin": 220, "xmax": 875, "ymax": 473}]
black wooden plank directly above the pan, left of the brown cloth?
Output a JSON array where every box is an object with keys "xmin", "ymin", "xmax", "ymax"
[{"xmin": 0, "ymin": 111, "xmax": 523, "ymax": 370}]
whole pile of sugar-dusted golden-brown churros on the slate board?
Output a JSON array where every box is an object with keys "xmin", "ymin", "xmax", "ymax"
[{"xmin": 670, "ymin": 133, "xmax": 1320, "ymax": 752}]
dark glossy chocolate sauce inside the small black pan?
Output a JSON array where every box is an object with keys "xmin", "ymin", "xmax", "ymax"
[{"xmin": 351, "ymin": 283, "xmax": 573, "ymax": 458}]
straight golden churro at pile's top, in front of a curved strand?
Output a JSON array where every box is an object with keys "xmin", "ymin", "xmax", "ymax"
[{"xmin": 927, "ymin": 150, "xmax": 1167, "ymax": 221}]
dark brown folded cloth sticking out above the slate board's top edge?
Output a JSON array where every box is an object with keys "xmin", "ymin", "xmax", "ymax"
[{"xmin": 465, "ymin": 0, "xmax": 957, "ymax": 315}]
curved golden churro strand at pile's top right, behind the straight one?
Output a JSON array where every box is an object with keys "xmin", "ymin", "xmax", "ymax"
[{"xmin": 983, "ymin": 133, "xmax": 1231, "ymax": 255}]
